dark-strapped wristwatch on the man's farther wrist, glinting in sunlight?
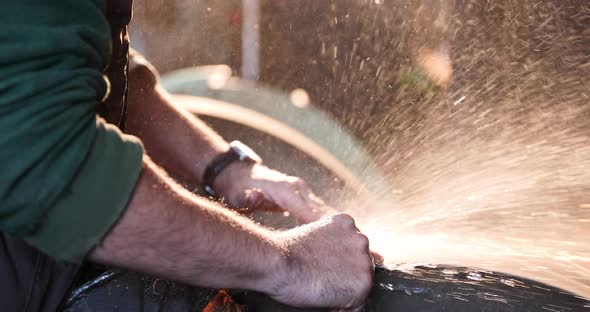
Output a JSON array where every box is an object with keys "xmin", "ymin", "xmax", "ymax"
[{"xmin": 203, "ymin": 141, "xmax": 262, "ymax": 197}]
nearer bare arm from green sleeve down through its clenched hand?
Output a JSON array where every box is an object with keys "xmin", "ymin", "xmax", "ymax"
[{"xmin": 90, "ymin": 159, "xmax": 373, "ymax": 309}]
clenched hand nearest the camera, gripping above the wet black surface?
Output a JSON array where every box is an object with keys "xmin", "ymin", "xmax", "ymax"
[{"xmin": 268, "ymin": 214, "xmax": 374, "ymax": 311}]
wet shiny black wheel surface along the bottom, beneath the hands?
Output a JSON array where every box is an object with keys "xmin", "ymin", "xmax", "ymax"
[{"xmin": 65, "ymin": 266, "xmax": 590, "ymax": 312}]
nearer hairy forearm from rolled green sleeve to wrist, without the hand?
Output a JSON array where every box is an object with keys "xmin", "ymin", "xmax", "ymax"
[{"xmin": 90, "ymin": 159, "xmax": 285, "ymax": 291}]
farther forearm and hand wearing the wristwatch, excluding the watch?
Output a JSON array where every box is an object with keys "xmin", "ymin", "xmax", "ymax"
[{"xmin": 126, "ymin": 62, "xmax": 342, "ymax": 222}]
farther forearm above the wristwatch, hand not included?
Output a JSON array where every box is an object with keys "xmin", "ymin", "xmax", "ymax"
[{"xmin": 126, "ymin": 68, "xmax": 228, "ymax": 184}]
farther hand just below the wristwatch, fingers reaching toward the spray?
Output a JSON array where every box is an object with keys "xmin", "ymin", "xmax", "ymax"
[{"xmin": 214, "ymin": 163, "xmax": 337, "ymax": 223}]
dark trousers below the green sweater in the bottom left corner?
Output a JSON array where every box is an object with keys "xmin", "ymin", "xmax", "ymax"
[{"xmin": 0, "ymin": 232, "xmax": 79, "ymax": 312}]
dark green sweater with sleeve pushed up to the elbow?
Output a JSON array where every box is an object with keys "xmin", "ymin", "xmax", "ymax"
[{"xmin": 0, "ymin": 0, "xmax": 143, "ymax": 262}]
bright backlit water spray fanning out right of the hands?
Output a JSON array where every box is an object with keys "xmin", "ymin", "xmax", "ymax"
[{"xmin": 342, "ymin": 1, "xmax": 590, "ymax": 298}]
